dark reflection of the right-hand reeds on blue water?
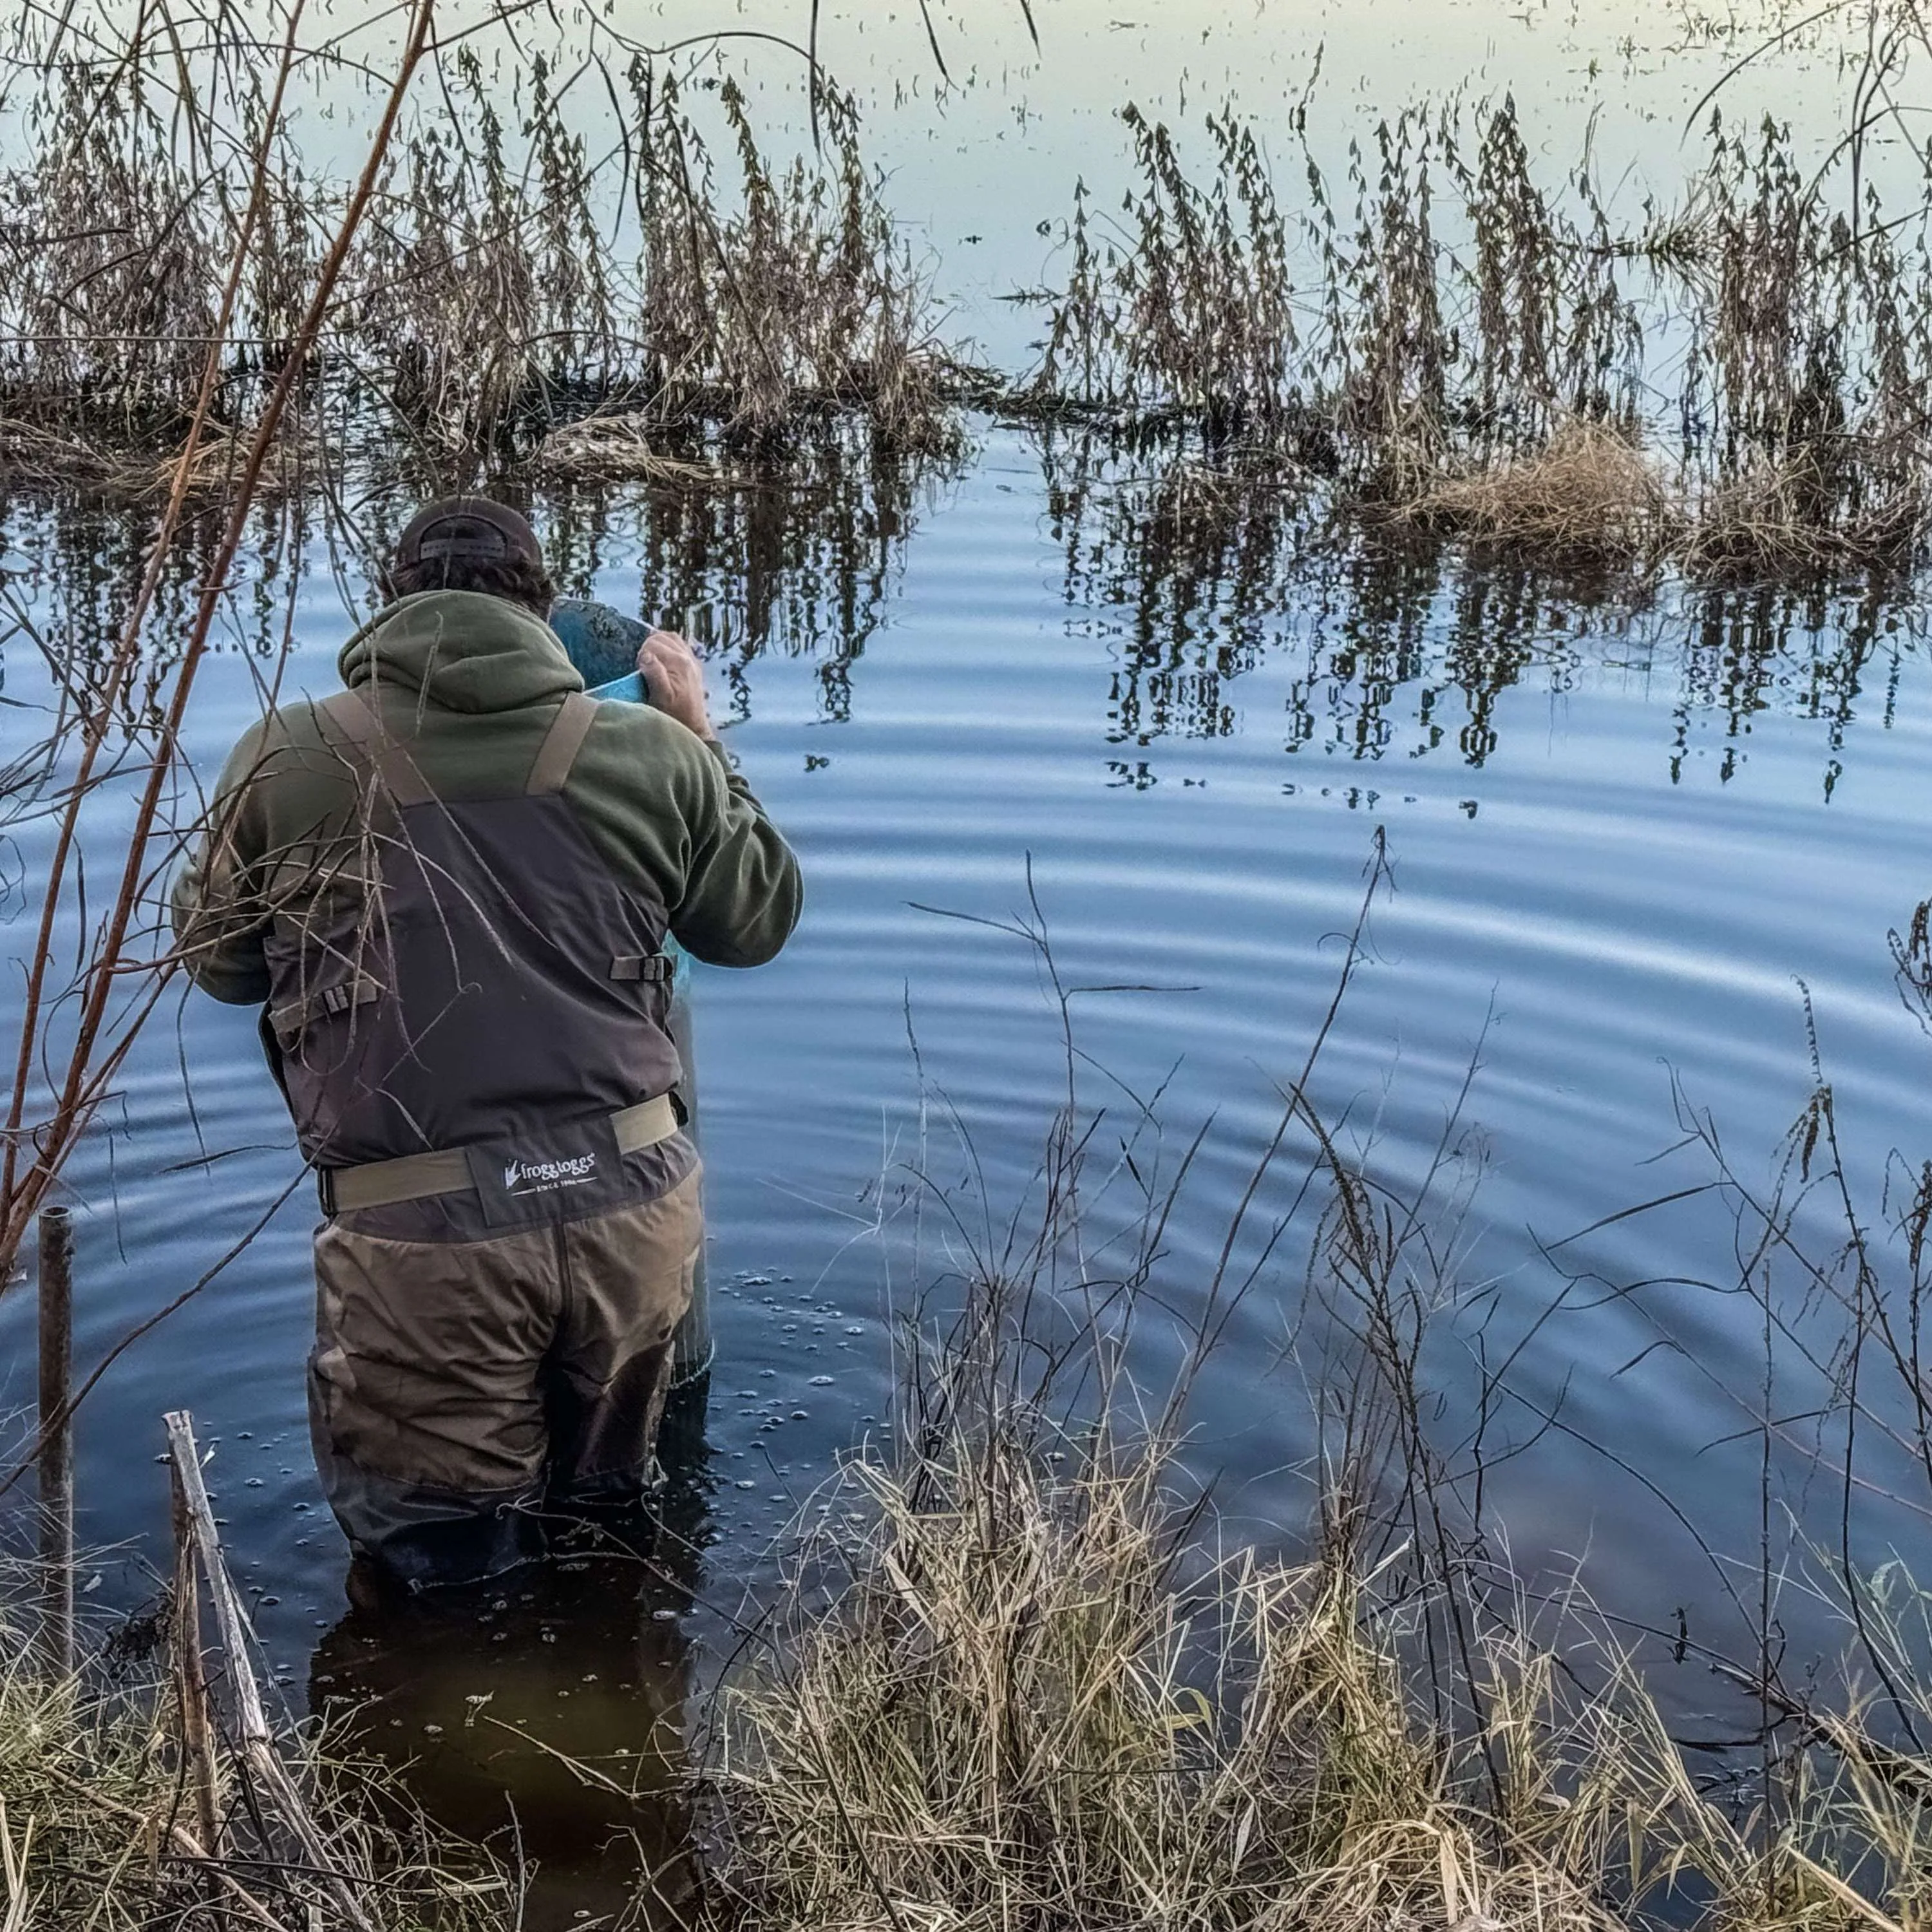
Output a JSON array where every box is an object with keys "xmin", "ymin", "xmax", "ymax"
[{"xmin": 1043, "ymin": 425, "xmax": 1924, "ymax": 790}]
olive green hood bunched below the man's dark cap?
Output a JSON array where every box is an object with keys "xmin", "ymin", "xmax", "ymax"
[{"xmin": 336, "ymin": 591, "xmax": 583, "ymax": 711}]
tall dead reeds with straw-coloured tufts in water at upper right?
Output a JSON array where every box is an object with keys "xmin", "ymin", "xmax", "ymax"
[{"xmin": 1028, "ymin": 99, "xmax": 1932, "ymax": 580}]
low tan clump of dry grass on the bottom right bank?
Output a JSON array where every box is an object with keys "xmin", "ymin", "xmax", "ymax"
[{"xmin": 713, "ymin": 1391, "xmax": 1932, "ymax": 1932}]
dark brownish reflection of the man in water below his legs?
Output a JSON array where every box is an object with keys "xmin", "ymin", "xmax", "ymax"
[{"xmin": 309, "ymin": 1389, "xmax": 713, "ymax": 1932}]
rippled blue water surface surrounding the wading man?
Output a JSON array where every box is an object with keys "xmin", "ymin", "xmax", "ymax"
[{"xmin": 0, "ymin": 433, "xmax": 1932, "ymax": 1917}]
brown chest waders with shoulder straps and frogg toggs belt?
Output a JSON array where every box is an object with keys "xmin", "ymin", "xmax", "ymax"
[{"xmin": 282, "ymin": 692, "xmax": 703, "ymax": 1586}]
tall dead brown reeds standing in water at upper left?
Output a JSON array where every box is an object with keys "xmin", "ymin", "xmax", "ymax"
[{"xmin": 0, "ymin": 39, "xmax": 956, "ymax": 489}]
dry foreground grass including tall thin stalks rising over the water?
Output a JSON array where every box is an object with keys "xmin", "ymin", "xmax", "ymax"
[{"xmin": 713, "ymin": 864, "xmax": 1932, "ymax": 1932}]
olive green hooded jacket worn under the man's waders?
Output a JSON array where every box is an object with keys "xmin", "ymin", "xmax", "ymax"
[{"xmin": 174, "ymin": 591, "xmax": 802, "ymax": 1005}]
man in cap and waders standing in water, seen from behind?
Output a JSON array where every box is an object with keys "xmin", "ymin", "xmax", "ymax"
[{"xmin": 174, "ymin": 498, "xmax": 800, "ymax": 1588}]
